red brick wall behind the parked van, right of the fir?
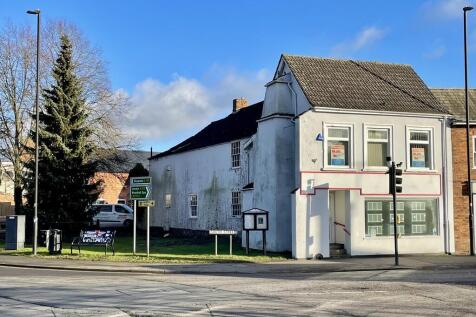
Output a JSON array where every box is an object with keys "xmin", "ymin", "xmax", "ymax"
[{"xmin": 94, "ymin": 172, "xmax": 129, "ymax": 204}]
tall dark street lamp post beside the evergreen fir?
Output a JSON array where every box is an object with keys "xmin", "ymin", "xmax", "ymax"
[{"xmin": 26, "ymin": 9, "xmax": 40, "ymax": 255}]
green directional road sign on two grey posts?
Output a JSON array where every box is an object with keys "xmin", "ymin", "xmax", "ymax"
[{"xmin": 130, "ymin": 176, "xmax": 155, "ymax": 256}]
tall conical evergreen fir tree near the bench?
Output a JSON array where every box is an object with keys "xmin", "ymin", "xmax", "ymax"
[{"xmin": 27, "ymin": 35, "xmax": 98, "ymax": 226}]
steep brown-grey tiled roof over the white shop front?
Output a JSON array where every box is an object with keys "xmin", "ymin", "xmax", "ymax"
[{"xmin": 283, "ymin": 55, "xmax": 448, "ymax": 114}]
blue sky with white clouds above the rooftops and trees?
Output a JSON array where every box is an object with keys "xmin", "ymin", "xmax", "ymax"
[{"xmin": 0, "ymin": 0, "xmax": 476, "ymax": 150}]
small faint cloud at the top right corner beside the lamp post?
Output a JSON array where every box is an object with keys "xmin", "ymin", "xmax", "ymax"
[{"xmin": 422, "ymin": 0, "xmax": 471, "ymax": 20}]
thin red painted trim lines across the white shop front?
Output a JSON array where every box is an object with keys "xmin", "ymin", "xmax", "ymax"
[{"xmin": 299, "ymin": 171, "xmax": 443, "ymax": 197}]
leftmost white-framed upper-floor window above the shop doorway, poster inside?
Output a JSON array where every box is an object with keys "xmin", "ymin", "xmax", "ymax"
[{"xmin": 326, "ymin": 126, "xmax": 352, "ymax": 167}]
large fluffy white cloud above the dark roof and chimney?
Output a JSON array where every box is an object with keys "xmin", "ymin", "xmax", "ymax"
[{"xmin": 124, "ymin": 66, "xmax": 270, "ymax": 140}]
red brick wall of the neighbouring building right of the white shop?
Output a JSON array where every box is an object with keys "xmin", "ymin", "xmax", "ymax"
[{"xmin": 451, "ymin": 126, "xmax": 476, "ymax": 254}]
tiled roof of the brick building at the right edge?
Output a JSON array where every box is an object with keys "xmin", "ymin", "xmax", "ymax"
[{"xmin": 431, "ymin": 88, "xmax": 476, "ymax": 121}]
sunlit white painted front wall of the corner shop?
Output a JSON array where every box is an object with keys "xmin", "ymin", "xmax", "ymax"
[{"xmin": 293, "ymin": 111, "xmax": 454, "ymax": 257}]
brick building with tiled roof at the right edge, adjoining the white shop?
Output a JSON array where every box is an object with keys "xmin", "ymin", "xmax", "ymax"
[{"xmin": 432, "ymin": 89, "xmax": 476, "ymax": 254}]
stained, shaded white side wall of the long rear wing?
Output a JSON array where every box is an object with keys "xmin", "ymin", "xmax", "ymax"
[{"xmin": 150, "ymin": 139, "xmax": 253, "ymax": 230}]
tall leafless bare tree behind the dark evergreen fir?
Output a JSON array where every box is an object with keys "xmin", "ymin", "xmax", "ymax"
[{"xmin": 0, "ymin": 21, "xmax": 135, "ymax": 213}]
